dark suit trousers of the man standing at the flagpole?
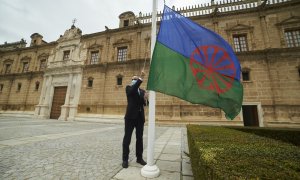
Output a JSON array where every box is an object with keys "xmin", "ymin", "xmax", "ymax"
[{"xmin": 123, "ymin": 114, "xmax": 144, "ymax": 161}]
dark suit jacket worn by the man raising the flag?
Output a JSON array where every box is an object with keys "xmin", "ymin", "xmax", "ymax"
[{"xmin": 125, "ymin": 79, "xmax": 146, "ymax": 122}]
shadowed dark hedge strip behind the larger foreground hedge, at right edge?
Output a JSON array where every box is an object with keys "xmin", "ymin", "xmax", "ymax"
[{"xmin": 230, "ymin": 127, "xmax": 300, "ymax": 146}]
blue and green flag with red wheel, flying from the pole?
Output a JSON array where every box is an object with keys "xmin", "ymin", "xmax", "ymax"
[{"xmin": 147, "ymin": 6, "xmax": 243, "ymax": 119}]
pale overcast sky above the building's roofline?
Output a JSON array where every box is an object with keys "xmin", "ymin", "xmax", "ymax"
[{"xmin": 0, "ymin": 0, "xmax": 210, "ymax": 46}]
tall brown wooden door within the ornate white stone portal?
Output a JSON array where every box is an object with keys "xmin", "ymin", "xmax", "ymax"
[{"xmin": 50, "ymin": 86, "xmax": 67, "ymax": 119}]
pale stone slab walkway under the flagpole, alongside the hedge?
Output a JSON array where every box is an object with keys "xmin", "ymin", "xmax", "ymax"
[{"xmin": 113, "ymin": 128, "xmax": 193, "ymax": 180}]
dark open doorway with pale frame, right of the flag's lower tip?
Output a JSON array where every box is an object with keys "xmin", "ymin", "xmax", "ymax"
[{"xmin": 242, "ymin": 105, "xmax": 259, "ymax": 127}]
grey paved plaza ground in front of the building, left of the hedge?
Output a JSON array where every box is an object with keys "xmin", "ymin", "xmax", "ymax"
[{"xmin": 0, "ymin": 115, "xmax": 193, "ymax": 180}]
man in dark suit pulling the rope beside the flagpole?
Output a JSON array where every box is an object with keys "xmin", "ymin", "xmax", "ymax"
[{"xmin": 122, "ymin": 72, "xmax": 148, "ymax": 168}]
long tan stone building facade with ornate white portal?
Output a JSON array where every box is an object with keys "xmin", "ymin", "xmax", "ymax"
[{"xmin": 0, "ymin": 0, "xmax": 300, "ymax": 127}]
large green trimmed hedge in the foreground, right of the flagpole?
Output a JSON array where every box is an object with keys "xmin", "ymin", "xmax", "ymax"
[{"xmin": 187, "ymin": 125, "xmax": 300, "ymax": 179}]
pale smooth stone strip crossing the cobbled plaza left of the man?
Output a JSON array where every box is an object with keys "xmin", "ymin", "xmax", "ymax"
[{"xmin": 0, "ymin": 127, "xmax": 121, "ymax": 147}]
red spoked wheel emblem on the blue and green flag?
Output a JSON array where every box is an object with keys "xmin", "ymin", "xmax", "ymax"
[{"xmin": 190, "ymin": 45, "xmax": 236, "ymax": 94}]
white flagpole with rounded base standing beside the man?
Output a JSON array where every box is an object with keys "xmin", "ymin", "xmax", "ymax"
[{"xmin": 141, "ymin": 0, "xmax": 160, "ymax": 178}]
